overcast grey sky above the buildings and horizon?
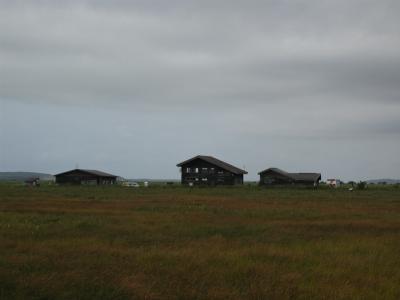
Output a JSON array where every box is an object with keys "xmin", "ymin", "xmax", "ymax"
[{"xmin": 0, "ymin": 0, "xmax": 400, "ymax": 180}]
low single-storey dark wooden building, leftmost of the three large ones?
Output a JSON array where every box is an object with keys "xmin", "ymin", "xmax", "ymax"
[{"xmin": 54, "ymin": 169, "xmax": 117, "ymax": 185}]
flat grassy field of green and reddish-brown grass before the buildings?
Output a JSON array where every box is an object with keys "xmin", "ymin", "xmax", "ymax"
[{"xmin": 0, "ymin": 184, "xmax": 400, "ymax": 299}]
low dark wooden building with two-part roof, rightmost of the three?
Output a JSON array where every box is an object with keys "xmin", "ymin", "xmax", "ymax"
[{"xmin": 258, "ymin": 168, "xmax": 321, "ymax": 186}]
